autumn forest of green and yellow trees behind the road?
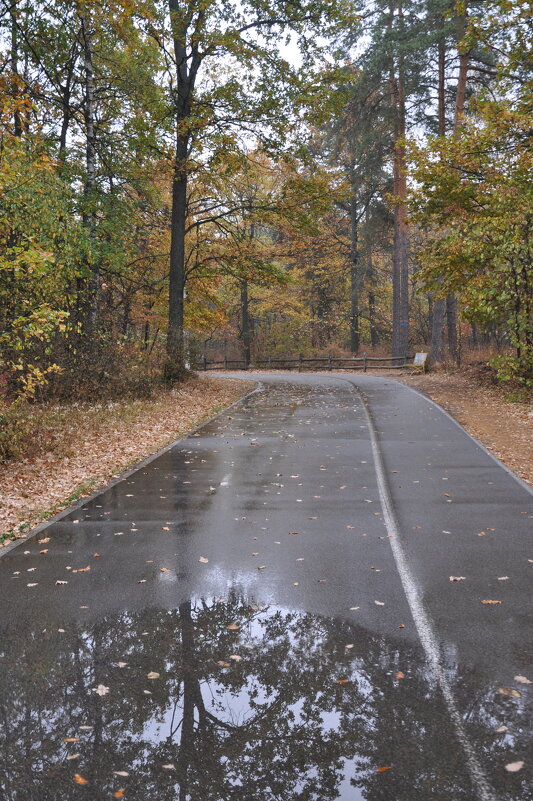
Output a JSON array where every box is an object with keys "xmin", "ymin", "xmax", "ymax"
[{"xmin": 0, "ymin": 0, "xmax": 533, "ymax": 405}]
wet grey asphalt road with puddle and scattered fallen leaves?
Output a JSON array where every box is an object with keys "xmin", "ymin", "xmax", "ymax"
[{"xmin": 0, "ymin": 375, "xmax": 533, "ymax": 801}]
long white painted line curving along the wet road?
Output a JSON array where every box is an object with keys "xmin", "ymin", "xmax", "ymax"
[{"xmin": 352, "ymin": 379, "xmax": 498, "ymax": 801}]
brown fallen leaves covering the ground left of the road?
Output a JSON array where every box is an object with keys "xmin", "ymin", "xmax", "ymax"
[{"xmin": 0, "ymin": 378, "xmax": 255, "ymax": 547}]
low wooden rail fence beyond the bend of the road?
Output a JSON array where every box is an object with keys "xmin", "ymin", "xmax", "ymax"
[{"xmin": 197, "ymin": 353, "xmax": 414, "ymax": 373}]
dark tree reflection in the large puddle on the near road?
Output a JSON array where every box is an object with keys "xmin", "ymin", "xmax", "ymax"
[{"xmin": 0, "ymin": 594, "xmax": 524, "ymax": 801}]
